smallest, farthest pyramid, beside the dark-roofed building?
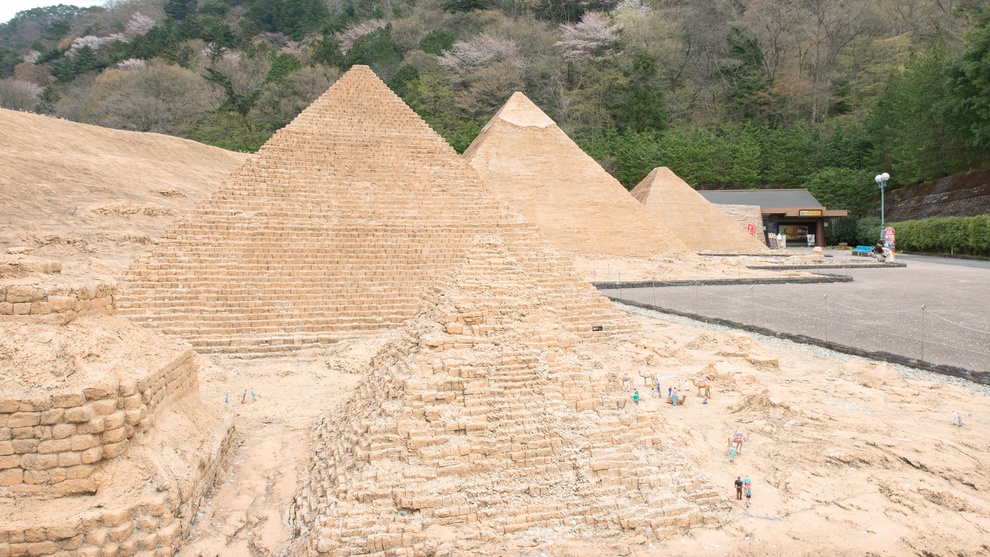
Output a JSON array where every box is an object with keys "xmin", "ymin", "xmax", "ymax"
[{"xmin": 632, "ymin": 166, "xmax": 769, "ymax": 254}]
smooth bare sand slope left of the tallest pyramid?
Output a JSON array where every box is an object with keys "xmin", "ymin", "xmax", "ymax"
[{"xmin": 0, "ymin": 109, "xmax": 249, "ymax": 269}]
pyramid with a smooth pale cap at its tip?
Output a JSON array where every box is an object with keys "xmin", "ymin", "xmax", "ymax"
[{"xmin": 464, "ymin": 92, "xmax": 690, "ymax": 257}]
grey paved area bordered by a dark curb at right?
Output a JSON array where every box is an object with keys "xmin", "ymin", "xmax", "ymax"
[{"xmin": 602, "ymin": 252, "xmax": 990, "ymax": 371}]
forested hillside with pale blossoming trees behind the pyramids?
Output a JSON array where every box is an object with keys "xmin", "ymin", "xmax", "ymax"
[{"xmin": 0, "ymin": 0, "xmax": 990, "ymax": 215}]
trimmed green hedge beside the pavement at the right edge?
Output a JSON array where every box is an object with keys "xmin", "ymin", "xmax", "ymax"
[{"xmin": 889, "ymin": 215, "xmax": 990, "ymax": 256}]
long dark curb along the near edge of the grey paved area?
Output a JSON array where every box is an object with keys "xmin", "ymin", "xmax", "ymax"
[{"xmin": 605, "ymin": 295, "xmax": 990, "ymax": 385}]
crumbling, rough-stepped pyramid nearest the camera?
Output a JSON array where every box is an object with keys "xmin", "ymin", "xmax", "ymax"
[{"xmin": 290, "ymin": 237, "xmax": 725, "ymax": 556}]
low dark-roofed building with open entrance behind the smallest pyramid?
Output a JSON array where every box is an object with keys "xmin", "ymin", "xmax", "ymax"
[{"xmin": 698, "ymin": 189, "xmax": 849, "ymax": 247}]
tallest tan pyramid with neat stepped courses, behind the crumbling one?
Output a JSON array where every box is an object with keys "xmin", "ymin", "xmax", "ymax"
[{"xmin": 118, "ymin": 66, "xmax": 628, "ymax": 355}]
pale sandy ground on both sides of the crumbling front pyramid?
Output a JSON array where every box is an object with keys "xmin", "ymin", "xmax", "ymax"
[{"xmin": 180, "ymin": 317, "xmax": 990, "ymax": 557}]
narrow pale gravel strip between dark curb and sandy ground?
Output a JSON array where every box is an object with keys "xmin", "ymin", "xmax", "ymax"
[{"xmin": 614, "ymin": 302, "xmax": 990, "ymax": 397}]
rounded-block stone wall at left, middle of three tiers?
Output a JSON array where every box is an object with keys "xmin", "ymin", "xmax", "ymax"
[{"xmin": 0, "ymin": 349, "xmax": 199, "ymax": 488}]
